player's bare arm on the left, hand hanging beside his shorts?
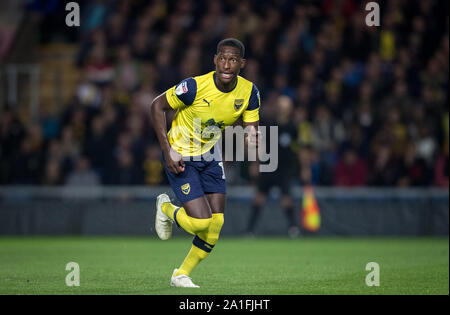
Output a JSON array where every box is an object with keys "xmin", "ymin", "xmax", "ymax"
[{"xmin": 150, "ymin": 93, "xmax": 185, "ymax": 174}]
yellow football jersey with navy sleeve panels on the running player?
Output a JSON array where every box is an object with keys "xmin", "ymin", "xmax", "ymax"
[{"xmin": 166, "ymin": 71, "xmax": 261, "ymax": 156}]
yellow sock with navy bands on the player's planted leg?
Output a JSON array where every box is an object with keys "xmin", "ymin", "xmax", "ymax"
[{"xmin": 175, "ymin": 213, "xmax": 224, "ymax": 276}]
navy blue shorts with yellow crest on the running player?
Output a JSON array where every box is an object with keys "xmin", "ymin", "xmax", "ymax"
[{"xmin": 163, "ymin": 157, "xmax": 226, "ymax": 203}]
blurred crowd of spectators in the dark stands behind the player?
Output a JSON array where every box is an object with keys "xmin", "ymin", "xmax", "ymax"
[{"xmin": 0, "ymin": 0, "xmax": 449, "ymax": 187}]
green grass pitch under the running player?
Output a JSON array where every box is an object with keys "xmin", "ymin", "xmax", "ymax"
[{"xmin": 0, "ymin": 237, "xmax": 449, "ymax": 295}]
